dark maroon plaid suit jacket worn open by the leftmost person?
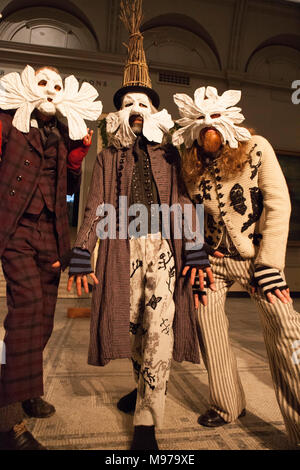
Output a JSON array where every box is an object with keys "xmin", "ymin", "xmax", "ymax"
[{"xmin": 0, "ymin": 112, "xmax": 81, "ymax": 269}]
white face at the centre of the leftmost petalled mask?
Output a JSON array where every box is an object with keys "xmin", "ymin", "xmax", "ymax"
[{"xmin": 35, "ymin": 69, "xmax": 63, "ymax": 116}]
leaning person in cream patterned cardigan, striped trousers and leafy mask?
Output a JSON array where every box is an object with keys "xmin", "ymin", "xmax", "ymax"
[{"xmin": 173, "ymin": 86, "xmax": 300, "ymax": 444}]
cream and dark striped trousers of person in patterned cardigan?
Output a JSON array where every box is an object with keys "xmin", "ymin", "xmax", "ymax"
[{"xmin": 197, "ymin": 257, "xmax": 300, "ymax": 444}]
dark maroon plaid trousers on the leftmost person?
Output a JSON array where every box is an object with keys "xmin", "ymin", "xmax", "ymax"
[{"xmin": 0, "ymin": 209, "xmax": 60, "ymax": 407}]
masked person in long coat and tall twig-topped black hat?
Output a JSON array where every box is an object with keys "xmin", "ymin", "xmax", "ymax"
[{"xmin": 69, "ymin": 0, "xmax": 217, "ymax": 450}]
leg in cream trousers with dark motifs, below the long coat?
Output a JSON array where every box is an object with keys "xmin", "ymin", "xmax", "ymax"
[{"xmin": 134, "ymin": 237, "xmax": 176, "ymax": 427}]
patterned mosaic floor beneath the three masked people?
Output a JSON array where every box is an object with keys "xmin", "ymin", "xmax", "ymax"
[{"xmin": 0, "ymin": 298, "xmax": 300, "ymax": 450}]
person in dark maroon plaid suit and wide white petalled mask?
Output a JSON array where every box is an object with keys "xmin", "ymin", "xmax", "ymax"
[{"xmin": 0, "ymin": 65, "xmax": 102, "ymax": 450}]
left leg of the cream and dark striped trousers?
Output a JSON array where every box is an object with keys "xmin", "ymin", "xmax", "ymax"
[{"xmin": 197, "ymin": 257, "xmax": 245, "ymax": 422}]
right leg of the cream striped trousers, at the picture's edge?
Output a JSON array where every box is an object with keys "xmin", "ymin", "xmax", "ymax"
[{"xmin": 225, "ymin": 260, "xmax": 300, "ymax": 444}]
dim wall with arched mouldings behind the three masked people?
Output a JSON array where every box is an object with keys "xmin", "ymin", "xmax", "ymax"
[{"xmin": 0, "ymin": 0, "xmax": 300, "ymax": 290}]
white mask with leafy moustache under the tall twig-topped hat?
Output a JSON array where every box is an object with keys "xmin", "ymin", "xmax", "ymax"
[{"xmin": 106, "ymin": 93, "xmax": 174, "ymax": 147}]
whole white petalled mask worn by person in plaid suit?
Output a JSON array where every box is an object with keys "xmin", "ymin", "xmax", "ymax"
[{"xmin": 0, "ymin": 65, "xmax": 102, "ymax": 140}]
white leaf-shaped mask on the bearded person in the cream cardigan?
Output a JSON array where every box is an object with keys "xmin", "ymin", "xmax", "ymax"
[{"xmin": 173, "ymin": 86, "xmax": 251, "ymax": 148}]
